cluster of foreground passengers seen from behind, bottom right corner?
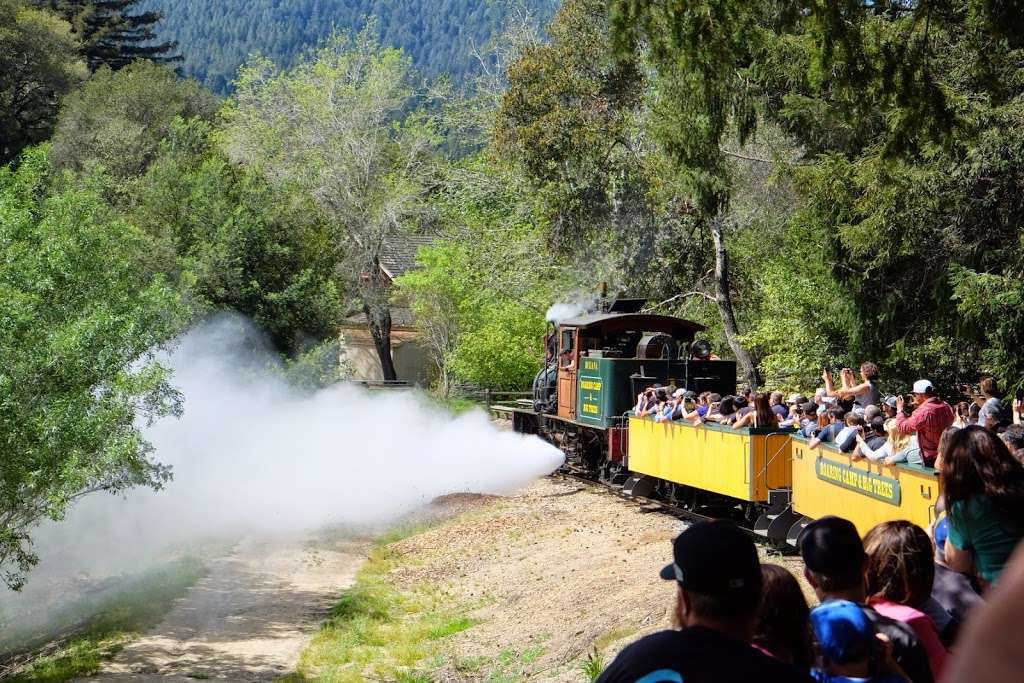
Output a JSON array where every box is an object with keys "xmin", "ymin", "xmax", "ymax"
[{"xmin": 598, "ymin": 509, "xmax": 1024, "ymax": 683}]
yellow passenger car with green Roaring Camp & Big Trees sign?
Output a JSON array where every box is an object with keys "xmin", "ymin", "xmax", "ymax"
[{"xmin": 790, "ymin": 437, "xmax": 940, "ymax": 542}]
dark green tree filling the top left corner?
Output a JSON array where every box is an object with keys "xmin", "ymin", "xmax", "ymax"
[{"xmin": 0, "ymin": 0, "xmax": 86, "ymax": 165}]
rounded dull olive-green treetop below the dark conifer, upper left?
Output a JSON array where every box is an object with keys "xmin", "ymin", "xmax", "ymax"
[{"xmin": 53, "ymin": 61, "xmax": 216, "ymax": 179}]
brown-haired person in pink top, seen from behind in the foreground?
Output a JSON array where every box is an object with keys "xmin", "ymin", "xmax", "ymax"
[{"xmin": 864, "ymin": 520, "xmax": 949, "ymax": 680}]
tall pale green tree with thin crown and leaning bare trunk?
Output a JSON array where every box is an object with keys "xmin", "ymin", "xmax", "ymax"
[{"xmin": 224, "ymin": 29, "xmax": 439, "ymax": 380}]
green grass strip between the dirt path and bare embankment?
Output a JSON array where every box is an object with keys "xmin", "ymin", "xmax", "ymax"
[{"xmin": 284, "ymin": 526, "xmax": 476, "ymax": 683}]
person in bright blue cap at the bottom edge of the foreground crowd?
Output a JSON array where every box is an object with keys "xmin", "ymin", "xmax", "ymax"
[{"xmin": 810, "ymin": 600, "xmax": 906, "ymax": 683}]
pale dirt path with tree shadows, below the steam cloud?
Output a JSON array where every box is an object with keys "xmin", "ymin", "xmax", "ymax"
[{"xmin": 81, "ymin": 539, "xmax": 365, "ymax": 681}]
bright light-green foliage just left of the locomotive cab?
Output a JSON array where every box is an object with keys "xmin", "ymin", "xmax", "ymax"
[{"xmin": 395, "ymin": 158, "xmax": 585, "ymax": 390}]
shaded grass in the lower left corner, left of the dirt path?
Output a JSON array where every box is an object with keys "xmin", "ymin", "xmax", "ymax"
[{"xmin": 0, "ymin": 557, "xmax": 206, "ymax": 683}]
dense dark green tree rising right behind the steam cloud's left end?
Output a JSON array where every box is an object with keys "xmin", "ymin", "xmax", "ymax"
[{"xmin": 127, "ymin": 119, "xmax": 342, "ymax": 352}]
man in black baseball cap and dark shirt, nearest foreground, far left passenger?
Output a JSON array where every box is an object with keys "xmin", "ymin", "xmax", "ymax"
[{"xmin": 598, "ymin": 520, "xmax": 811, "ymax": 683}]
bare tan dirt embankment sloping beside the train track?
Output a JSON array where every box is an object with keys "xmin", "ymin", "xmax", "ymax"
[{"xmin": 390, "ymin": 478, "xmax": 806, "ymax": 683}]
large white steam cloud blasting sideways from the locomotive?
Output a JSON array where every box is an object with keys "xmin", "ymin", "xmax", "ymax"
[{"xmin": 2, "ymin": 315, "xmax": 562, "ymax": 602}]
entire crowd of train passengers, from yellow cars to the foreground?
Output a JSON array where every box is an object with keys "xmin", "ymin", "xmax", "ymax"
[{"xmin": 600, "ymin": 362, "xmax": 1024, "ymax": 683}]
